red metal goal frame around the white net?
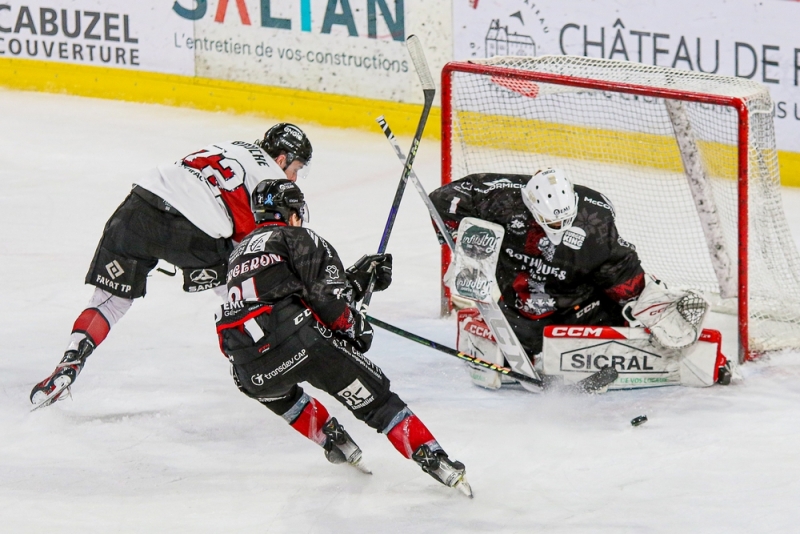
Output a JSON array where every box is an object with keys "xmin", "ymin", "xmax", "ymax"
[{"xmin": 441, "ymin": 61, "xmax": 757, "ymax": 363}]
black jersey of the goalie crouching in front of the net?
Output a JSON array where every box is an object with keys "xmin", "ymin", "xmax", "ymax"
[{"xmin": 430, "ymin": 173, "xmax": 644, "ymax": 319}]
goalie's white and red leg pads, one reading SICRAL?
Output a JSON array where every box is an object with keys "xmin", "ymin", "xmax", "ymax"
[{"xmin": 458, "ymin": 308, "xmax": 731, "ymax": 390}]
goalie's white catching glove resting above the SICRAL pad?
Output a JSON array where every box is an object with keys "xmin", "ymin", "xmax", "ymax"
[{"xmin": 622, "ymin": 276, "xmax": 709, "ymax": 349}]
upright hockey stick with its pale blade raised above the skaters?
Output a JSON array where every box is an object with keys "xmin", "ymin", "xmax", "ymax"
[{"xmin": 361, "ymin": 35, "xmax": 436, "ymax": 311}]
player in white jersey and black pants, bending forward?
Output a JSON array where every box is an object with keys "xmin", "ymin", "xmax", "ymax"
[{"xmin": 30, "ymin": 123, "xmax": 312, "ymax": 407}]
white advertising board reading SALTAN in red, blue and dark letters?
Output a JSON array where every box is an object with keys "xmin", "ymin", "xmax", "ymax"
[{"xmin": 171, "ymin": 0, "xmax": 452, "ymax": 102}]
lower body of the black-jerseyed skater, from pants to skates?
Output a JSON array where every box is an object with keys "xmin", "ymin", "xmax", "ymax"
[{"xmin": 217, "ymin": 307, "xmax": 469, "ymax": 491}]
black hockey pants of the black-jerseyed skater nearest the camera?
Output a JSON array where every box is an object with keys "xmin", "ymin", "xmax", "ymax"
[{"xmin": 220, "ymin": 302, "xmax": 406, "ymax": 431}]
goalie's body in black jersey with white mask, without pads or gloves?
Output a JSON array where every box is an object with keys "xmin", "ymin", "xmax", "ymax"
[{"xmin": 430, "ymin": 168, "xmax": 645, "ymax": 364}]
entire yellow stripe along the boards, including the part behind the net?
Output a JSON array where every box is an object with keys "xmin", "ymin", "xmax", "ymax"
[{"xmin": 0, "ymin": 58, "xmax": 800, "ymax": 187}]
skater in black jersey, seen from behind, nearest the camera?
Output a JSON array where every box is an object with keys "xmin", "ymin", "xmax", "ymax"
[{"xmin": 217, "ymin": 180, "xmax": 471, "ymax": 496}]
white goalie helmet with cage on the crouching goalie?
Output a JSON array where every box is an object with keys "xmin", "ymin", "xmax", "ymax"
[{"xmin": 522, "ymin": 167, "xmax": 578, "ymax": 242}]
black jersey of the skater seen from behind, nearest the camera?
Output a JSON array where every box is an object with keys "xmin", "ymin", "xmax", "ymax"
[{"xmin": 222, "ymin": 223, "xmax": 353, "ymax": 334}]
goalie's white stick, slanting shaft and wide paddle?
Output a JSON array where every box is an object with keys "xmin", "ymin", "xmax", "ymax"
[{"xmin": 376, "ymin": 116, "xmax": 613, "ymax": 394}]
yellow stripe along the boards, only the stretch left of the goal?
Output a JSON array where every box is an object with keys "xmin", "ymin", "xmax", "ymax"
[{"xmin": 0, "ymin": 58, "xmax": 440, "ymax": 140}]
